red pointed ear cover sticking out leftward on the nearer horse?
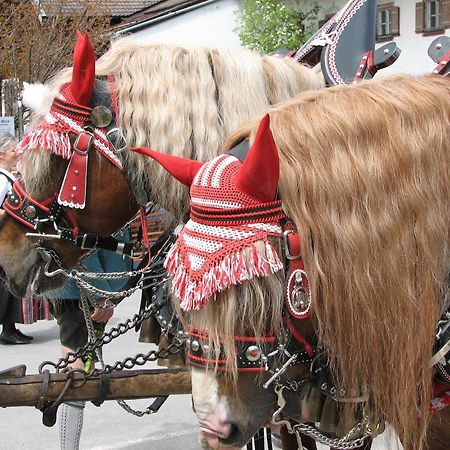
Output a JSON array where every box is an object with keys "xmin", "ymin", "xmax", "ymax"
[{"xmin": 130, "ymin": 147, "xmax": 203, "ymax": 186}]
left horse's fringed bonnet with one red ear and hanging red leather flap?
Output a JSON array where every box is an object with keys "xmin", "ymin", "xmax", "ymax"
[{"xmin": 16, "ymin": 31, "xmax": 123, "ymax": 208}]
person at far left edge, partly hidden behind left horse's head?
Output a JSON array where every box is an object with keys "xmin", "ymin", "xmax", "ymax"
[{"xmin": 0, "ymin": 133, "xmax": 33, "ymax": 345}]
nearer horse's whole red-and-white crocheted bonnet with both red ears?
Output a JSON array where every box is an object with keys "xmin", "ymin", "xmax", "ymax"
[{"xmin": 133, "ymin": 115, "xmax": 284, "ymax": 310}]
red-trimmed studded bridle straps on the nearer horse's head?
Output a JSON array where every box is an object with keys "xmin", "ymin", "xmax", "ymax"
[{"xmin": 186, "ymin": 140, "xmax": 316, "ymax": 372}]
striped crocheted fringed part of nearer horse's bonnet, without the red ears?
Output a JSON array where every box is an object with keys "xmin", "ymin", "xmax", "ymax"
[{"xmin": 166, "ymin": 155, "xmax": 284, "ymax": 310}]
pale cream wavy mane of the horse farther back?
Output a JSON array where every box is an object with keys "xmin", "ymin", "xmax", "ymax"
[{"xmin": 24, "ymin": 39, "xmax": 323, "ymax": 217}]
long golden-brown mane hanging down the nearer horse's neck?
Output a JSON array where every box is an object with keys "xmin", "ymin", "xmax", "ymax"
[{"xmin": 193, "ymin": 76, "xmax": 450, "ymax": 449}]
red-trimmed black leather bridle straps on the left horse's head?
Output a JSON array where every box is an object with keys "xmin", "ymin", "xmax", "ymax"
[{"xmin": 2, "ymin": 77, "xmax": 146, "ymax": 256}]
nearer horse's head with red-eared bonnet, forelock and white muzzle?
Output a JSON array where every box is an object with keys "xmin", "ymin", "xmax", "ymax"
[{"xmin": 133, "ymin": 115, "xmax": 316, "ymax": 446}]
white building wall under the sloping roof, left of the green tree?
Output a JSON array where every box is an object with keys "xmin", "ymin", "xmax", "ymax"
[{"xmin": 125, "ymin": 0, "xmax": 241, "ymax": 48}]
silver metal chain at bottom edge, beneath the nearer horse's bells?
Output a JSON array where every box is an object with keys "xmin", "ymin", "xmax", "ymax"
[{"xmin": 292, "ymin": 417, "xmax": 372, "ymax": 450}]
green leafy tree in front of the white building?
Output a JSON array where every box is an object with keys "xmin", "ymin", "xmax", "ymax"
[{"xmin": 237, "ymin": 0, "xmax": 319, "ymax": 53}]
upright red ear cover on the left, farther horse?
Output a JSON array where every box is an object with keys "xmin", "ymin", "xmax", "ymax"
[{"xmin": 69, "ymin": 30, "xmax": 95, "ymax": 106}]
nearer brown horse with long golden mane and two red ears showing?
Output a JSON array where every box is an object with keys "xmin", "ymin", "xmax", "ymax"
[{"xmin": 138, "ymin": 76, "xmax": 450, "ymax": 450}]
